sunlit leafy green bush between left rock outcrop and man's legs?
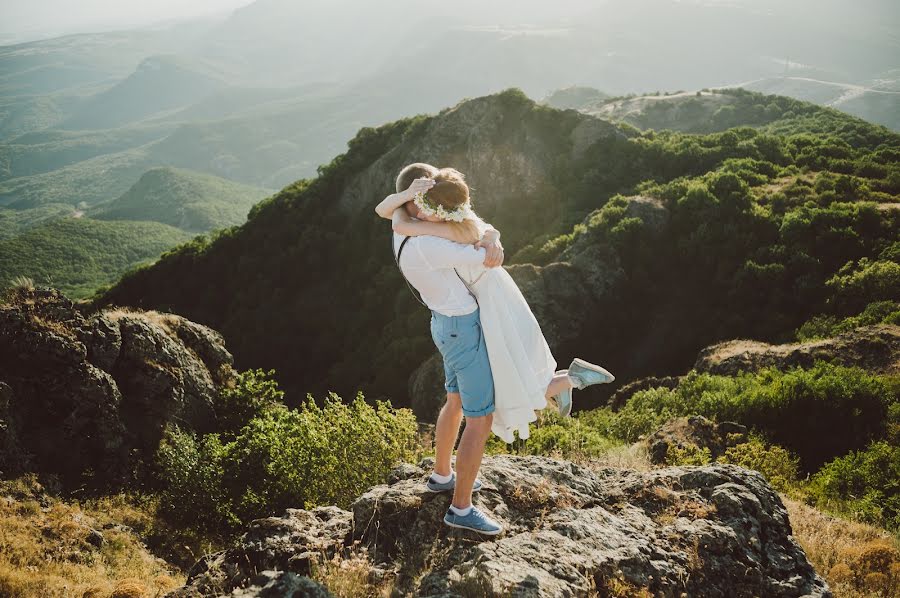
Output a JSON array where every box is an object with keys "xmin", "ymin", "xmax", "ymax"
[{"xmin": 157, "ymin": 370, "xmax": 416, "ymax": 533}]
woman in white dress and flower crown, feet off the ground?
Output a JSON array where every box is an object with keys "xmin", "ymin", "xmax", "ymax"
[{"xmin": 376, "ymin": 168, "xmax": 615, "ymax": 443}]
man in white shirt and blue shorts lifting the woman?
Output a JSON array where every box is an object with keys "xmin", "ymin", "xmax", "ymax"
[{"xmin": 376, "ymin": 164, "xmax": 503, "ymax": 535}]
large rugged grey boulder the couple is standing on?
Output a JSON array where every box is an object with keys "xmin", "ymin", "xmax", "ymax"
[{"xmin": 170, "ymin": 456, "xmax": 831, "ymax": 597}]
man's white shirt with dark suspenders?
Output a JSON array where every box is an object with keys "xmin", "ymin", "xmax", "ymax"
[{"xmin": 394, "ymin": 233, "xmax": 487, "ymax": 316}]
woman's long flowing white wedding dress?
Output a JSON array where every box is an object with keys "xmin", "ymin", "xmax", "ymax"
[{"xmin": 456, "ymin": 255, "xmax": 556, "ymax": 443}]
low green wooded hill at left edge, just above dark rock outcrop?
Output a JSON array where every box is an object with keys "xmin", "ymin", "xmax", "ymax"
[{"xmin": 0, "ymin": 218, "xmax": 190, "ymax": 298}]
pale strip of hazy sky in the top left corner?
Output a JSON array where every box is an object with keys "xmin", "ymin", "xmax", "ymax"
[{"xmin": 0, "ymin": 0, "xmax": 253, "ymax": 43}]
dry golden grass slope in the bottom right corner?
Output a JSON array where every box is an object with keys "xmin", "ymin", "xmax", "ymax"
[{"xmin": 781, "ymin": 494, "xmax": 900, "ymax": 598}]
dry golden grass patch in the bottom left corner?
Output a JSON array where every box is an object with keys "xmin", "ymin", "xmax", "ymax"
[{"xmin": 0, "ymin": 476, "xmax": 184, "ymax": 598}]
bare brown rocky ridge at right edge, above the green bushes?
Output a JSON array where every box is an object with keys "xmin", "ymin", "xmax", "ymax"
[{"xmin": 694, "ymin": 324, "xmax": 900, "ymax": 376}]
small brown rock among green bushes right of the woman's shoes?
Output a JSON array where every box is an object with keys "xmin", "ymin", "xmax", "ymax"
[{"xmin": 641, "ymin": 415, "xmax": 747, "ymax": 465}]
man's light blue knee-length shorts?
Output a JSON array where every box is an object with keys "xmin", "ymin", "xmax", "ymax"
[{"xmin": 431, "ymin": 309, "xmax": 494, "ymax": 417}]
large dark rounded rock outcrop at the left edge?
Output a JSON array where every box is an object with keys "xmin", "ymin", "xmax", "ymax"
[{"xmin": 0, "ymin": 288, "xmax": 233, "ymax": 490}]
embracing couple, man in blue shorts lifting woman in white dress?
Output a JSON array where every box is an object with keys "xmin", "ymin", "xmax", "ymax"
[{"xmin": 375, "ymin": 163, "xmax": 615, "ymax": 535}]
